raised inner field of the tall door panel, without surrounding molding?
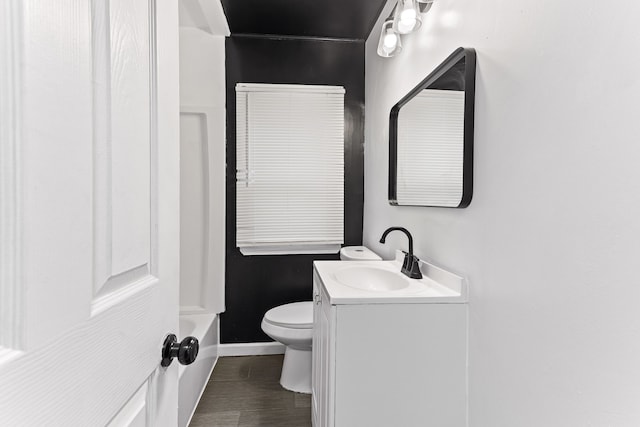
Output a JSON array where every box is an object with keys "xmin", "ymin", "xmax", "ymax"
[{"xmin": 110, "ymin": 0, "xmax": 155, "ymax": 277}]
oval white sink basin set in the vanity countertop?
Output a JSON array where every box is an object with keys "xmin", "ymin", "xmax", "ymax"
[{"xmin": 334, "ymin": 265, "xmax": 410, "ymax": 292}]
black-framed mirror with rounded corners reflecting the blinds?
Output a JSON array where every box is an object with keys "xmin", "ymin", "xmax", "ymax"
[{"xmin": 389, "ymin": 48, "xmax": 476, "ymax": 208}]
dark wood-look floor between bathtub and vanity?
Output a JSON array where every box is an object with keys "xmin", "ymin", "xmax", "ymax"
[{"xmin": 190, "ymin": 355, "xmax": 311, "ymax": 427}]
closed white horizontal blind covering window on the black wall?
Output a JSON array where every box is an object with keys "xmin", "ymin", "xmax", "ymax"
[{"xmin": 236, "ymin": 83, "xmax": 344, "ymax": 255}]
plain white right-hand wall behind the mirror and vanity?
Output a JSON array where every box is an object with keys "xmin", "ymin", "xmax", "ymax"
[{"xmin": 364, "ymin": 0, "xmax": 640, "ymax": 427}]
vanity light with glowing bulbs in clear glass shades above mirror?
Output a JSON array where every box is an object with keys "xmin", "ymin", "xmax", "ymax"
[{"xmin": 377, "ymin": 0, "xmax": 434, "ymax": 58}]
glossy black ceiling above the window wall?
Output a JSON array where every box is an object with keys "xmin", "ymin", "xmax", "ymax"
[{"xmin": 222, "ymin": 0, "xmax": 386, "ymax": 40}]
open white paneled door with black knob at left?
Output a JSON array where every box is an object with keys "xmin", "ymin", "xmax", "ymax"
[{"xmin": 0, "ymin": 0, "xmax": 180, "ymax": 427}]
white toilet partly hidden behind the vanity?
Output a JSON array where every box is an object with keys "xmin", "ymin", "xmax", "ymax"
[{"xmin": 261, "ymin": 246, "xmax": 382, "ymax": 394}]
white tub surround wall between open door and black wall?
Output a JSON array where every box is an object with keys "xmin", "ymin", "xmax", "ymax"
[{"xmin": 180, "ymin": 27, "xmax": 226, "ymax": 313}]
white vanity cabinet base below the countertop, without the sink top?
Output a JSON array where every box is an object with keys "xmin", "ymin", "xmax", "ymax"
[{"xmin": 312, "ymin": 267, "xmax": 467, "ymax": 427}]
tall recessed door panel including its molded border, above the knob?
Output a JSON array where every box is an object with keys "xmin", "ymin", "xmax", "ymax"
[{"xmin": 92, "ymin": 0, "xmax": 157, "ymax": 297}]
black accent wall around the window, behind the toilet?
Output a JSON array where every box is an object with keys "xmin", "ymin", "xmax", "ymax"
[{"xmin": 220, "ymin": 36, "xmax": 364, "ymax": 343}]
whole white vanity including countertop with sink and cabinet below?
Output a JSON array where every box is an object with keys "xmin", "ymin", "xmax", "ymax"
[{"xmin": 312, "ymin": 254, "xmax": 467, "ymax": 427}]
